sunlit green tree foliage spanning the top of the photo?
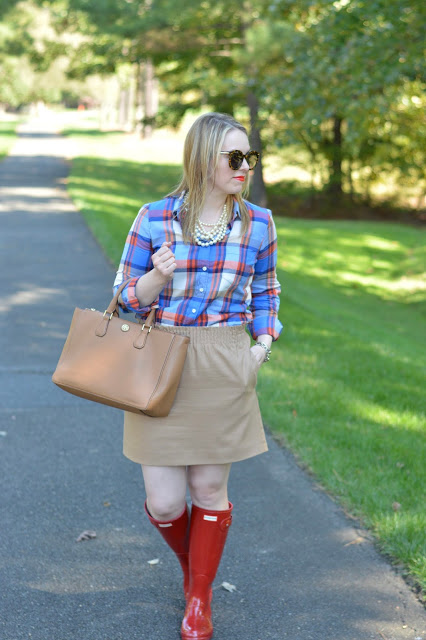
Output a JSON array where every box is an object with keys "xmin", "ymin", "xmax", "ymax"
[{"xmin": 0, "ymin": 0, "xmax": 426, "ymax": 203}]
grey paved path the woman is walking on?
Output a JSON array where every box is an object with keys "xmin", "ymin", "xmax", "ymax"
[{"xmin": 0, "ymin": 121, "xmax": 426, "ymax": 640}]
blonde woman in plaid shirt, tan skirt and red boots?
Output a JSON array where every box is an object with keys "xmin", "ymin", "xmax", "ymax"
[{"xmin": 114, "ymin": 113, "xmax": 282, "ymax": 640}]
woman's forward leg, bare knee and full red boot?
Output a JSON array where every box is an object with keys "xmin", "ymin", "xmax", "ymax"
[{"xmin": 181, "ymin": 464, "xmax": 232, "ymax": 640}]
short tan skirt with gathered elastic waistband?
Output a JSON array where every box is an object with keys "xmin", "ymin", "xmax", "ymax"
[{"xmin": 123, "ymin": 325, "xmax": 268, "ymax": 466}]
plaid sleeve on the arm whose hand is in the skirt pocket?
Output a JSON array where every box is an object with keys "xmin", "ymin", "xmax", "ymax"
[{"xmin": 248, "ymin": 212, "xmax": 283, "ymax": 340}]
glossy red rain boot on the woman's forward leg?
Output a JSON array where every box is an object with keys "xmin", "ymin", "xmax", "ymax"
[{"xmin": 181, "ymin": 503, "xmax": 233, "ymax": 640}]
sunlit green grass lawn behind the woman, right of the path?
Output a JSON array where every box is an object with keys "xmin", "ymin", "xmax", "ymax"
[{"xmin": 64, "ymin": 126, "xmax": 426, "ymax": 600}]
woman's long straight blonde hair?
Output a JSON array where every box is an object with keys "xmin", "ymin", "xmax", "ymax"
[{"xmin": 168, "ymin": 112, "xmax": 250, "ymax": 242}]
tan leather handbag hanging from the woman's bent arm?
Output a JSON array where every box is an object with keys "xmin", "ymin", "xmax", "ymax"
[{"xmin": 52, "ymin": 282, "xmax": 189, "ymax": 417}]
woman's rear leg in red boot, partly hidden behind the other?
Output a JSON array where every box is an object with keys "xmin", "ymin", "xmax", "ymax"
[{"xmin": 142, "ymin": 465, "xmax": 189, "ymax": 597}]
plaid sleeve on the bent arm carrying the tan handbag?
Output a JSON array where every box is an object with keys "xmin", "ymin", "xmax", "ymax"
[{"xmin": 113, "ymin": 205, "xmax": 153, "ymax": 315}]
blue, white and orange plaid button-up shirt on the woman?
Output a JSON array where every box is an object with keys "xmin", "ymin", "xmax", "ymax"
[{"xmin": 114, "ymin": 197, "xmax": 282, "ymax": 340}]
